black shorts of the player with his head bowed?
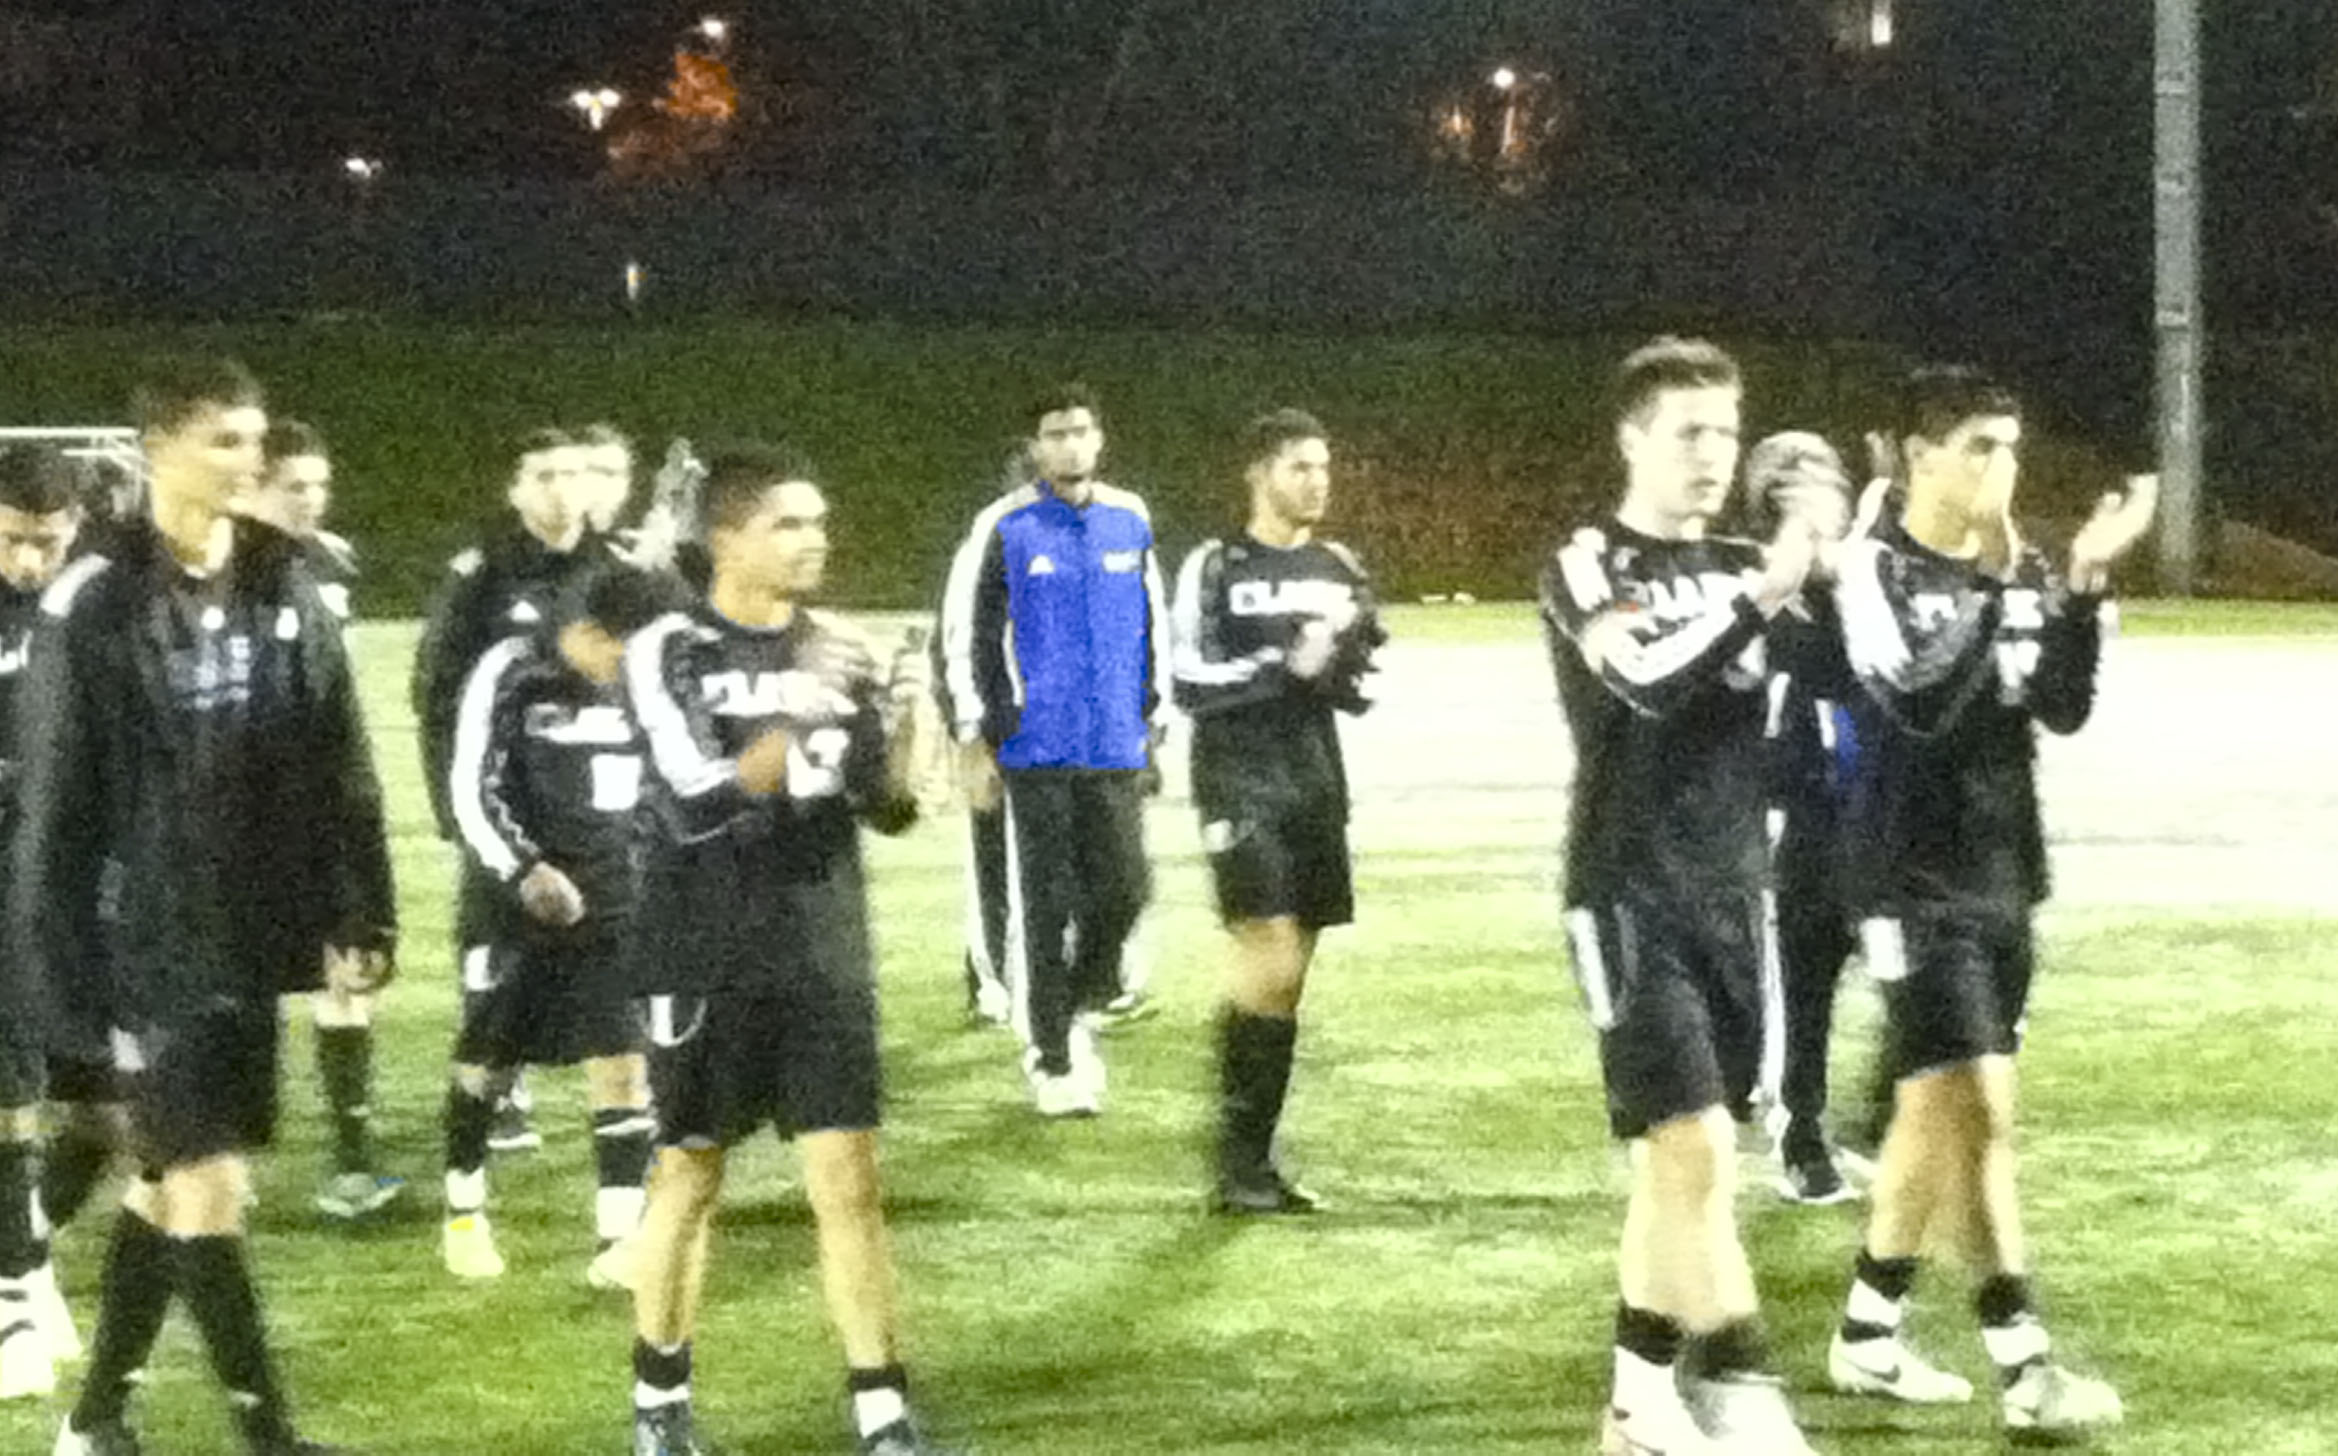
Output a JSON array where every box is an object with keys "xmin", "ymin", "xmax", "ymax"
[{"xmin": 454, "ymin": 932, "xmax": 641, "ymax": 1068}]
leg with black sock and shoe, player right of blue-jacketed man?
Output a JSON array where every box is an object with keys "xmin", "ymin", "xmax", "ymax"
[{"xmin": 1216, "ymin": 916, "xmax": 1316, "ymax": 1213}]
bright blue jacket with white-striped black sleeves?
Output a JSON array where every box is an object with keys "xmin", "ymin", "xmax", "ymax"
[{"xmin": 942, "ymin": 481, "xmax": 1169, "ymax": 771}]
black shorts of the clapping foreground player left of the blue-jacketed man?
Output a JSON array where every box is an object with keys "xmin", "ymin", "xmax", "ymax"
[{"xmin": 643, "ymin": 975, "xmax": 884, "ymax": 1148}]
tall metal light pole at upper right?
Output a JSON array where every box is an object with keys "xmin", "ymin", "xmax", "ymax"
[{"xmin": 2153, "ymin": 0, "xmax": 2205, "ymax": 596}]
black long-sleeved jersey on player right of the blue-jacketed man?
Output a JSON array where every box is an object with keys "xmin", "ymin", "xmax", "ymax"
[{"xmin": 1171, "ymin": 535, "xmax": 1386, "ymax": 820}]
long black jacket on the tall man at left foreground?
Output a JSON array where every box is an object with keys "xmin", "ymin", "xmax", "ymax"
[{"xmin": 9, "ymin": 521, "xmax": 397, "ymax": 1028}]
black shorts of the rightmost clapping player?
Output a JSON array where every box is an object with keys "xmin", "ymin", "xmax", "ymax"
[{"xmin": 1861, "ymin": 907, "xmax": 2036, "ymax": 1077}]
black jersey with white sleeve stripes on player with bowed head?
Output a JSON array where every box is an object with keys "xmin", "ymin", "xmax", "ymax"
[{"xmin": 449, "ymin": 633, "xmax": 641, "ymax": 928}]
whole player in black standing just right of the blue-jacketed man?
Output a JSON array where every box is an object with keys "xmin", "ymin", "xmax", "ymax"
[{"xmin": 1171, "ymin": 409, "xmax": 1386, "ymax": 1213}]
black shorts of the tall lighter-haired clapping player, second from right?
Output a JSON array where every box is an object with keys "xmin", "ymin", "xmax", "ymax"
[{"xmin": 1566, "ymin": 893, "xmax": 1784, "ymax": 1138}]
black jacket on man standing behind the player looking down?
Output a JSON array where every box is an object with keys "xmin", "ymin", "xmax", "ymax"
[{"xmin": 409, "ymin": 516, "xmax": 615, "ymax": 839}]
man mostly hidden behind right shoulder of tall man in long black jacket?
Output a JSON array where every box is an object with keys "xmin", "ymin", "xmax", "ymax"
[{"xmin": 236, "ymin": 418, "xmax": 407, "ymax": 1220}]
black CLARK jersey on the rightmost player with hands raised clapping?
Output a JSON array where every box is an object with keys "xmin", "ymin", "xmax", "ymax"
[{"xmin": 1842, "ymin": 526, "xmax": 2102, "ymax": 916}]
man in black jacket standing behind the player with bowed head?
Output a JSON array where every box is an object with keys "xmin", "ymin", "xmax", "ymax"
[{"xmin": 411, "ymin": 430, "xmax": 624, "ymax": 1152}]
